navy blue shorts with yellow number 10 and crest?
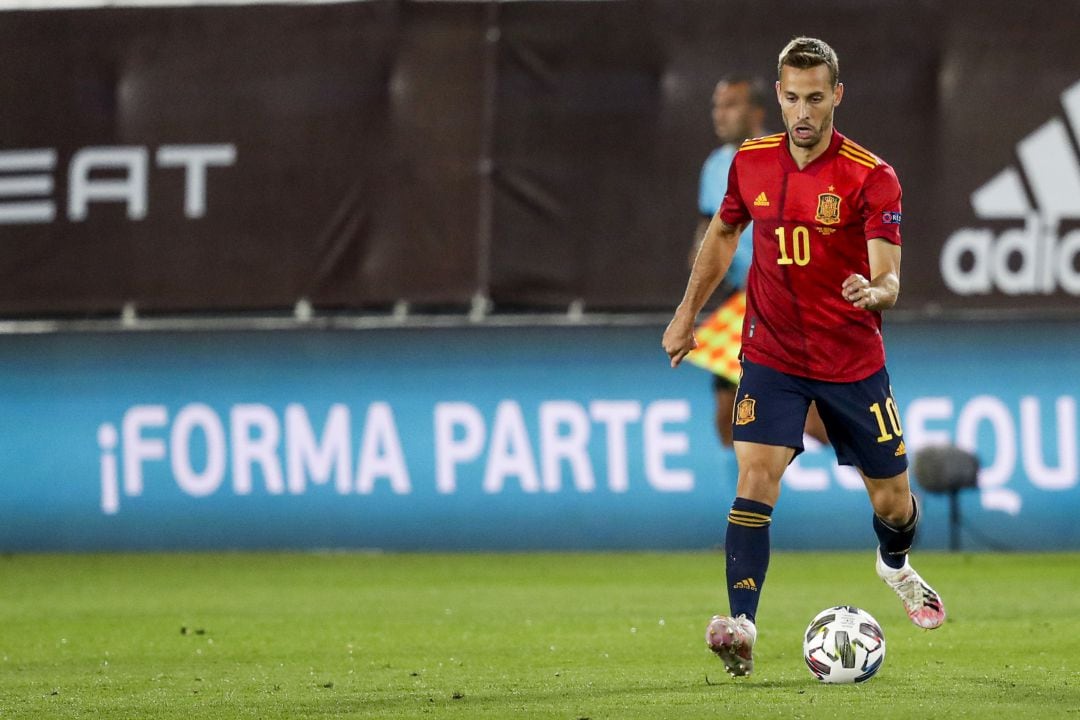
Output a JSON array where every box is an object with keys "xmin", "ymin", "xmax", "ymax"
[{"xmin": 732, "ymin": 358, "xmax": 907, "ymax": 478}]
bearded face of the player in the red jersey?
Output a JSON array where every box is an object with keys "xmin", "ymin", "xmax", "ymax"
[{"xmin": 777, "ymin": 65, "xmax": 843, "ymax": 149}]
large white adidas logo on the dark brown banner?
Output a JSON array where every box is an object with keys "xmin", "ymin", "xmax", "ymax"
[{"xmin": 941, "ymin": 76, "xmax": 1080, "ymax": 296}]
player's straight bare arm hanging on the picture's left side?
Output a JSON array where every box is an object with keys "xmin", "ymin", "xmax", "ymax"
[{"xmin": 663, "ymin": 213, "xmax": 746, "ymax": 367}]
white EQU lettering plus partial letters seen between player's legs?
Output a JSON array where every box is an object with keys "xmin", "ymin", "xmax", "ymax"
[{"xmin": 784, "ymin": 395, "xmax": 1080, "ymax": 515}]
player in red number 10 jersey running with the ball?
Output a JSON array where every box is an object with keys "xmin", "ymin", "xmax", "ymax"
[{"xmin": 663, "ymin": 38, "xmax": 945, "ymax": 676}]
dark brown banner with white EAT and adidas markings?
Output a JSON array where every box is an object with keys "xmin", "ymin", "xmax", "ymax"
[{"xmin": 0, "ymin": 0, "xmax": 1080, "ymax": 316}]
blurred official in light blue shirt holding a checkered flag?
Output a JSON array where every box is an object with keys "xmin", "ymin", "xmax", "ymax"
[{"xmin": 687, "ymin": 74, "xmax": 828, "ymax": 448}]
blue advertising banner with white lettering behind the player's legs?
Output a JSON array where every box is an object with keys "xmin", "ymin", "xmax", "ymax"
[{"xmin": 0, "ymin": 323, "xmax": 1080, "ymax": 552}]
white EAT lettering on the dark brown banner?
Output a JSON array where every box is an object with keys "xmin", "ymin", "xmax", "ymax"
[{"xmin": 0, "ymin": 144, "xmax": 237, "ymax": 225}]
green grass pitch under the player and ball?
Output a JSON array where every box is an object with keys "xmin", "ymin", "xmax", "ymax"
[{"xmin": 0, "ymin": 552, "xmax": 1080, "ymax": 720}]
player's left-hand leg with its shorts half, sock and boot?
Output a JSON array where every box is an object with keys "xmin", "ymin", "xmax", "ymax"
[{"xmin": 706, "ymin": 363, "xmax": 810, "ymax": 676}]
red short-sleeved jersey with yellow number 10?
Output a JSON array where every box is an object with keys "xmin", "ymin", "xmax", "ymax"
[{"xmin": 720, "ymin": 131, "xmax": 901, "ymax": 382}]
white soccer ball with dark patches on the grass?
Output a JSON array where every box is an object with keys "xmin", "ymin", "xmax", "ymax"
[{"xmin": 802, "ymin": 604, "xmax": 885, "ymax": 682}]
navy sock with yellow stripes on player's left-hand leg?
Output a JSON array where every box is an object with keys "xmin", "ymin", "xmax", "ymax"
[{"xmin": 724, "ymin": 498, "xmax": 772, "ymax": 622}]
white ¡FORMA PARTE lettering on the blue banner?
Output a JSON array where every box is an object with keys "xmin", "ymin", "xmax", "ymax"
[{"xmin": 97, "ymin": 399, "xmax": 694, "ymax": 515}]
